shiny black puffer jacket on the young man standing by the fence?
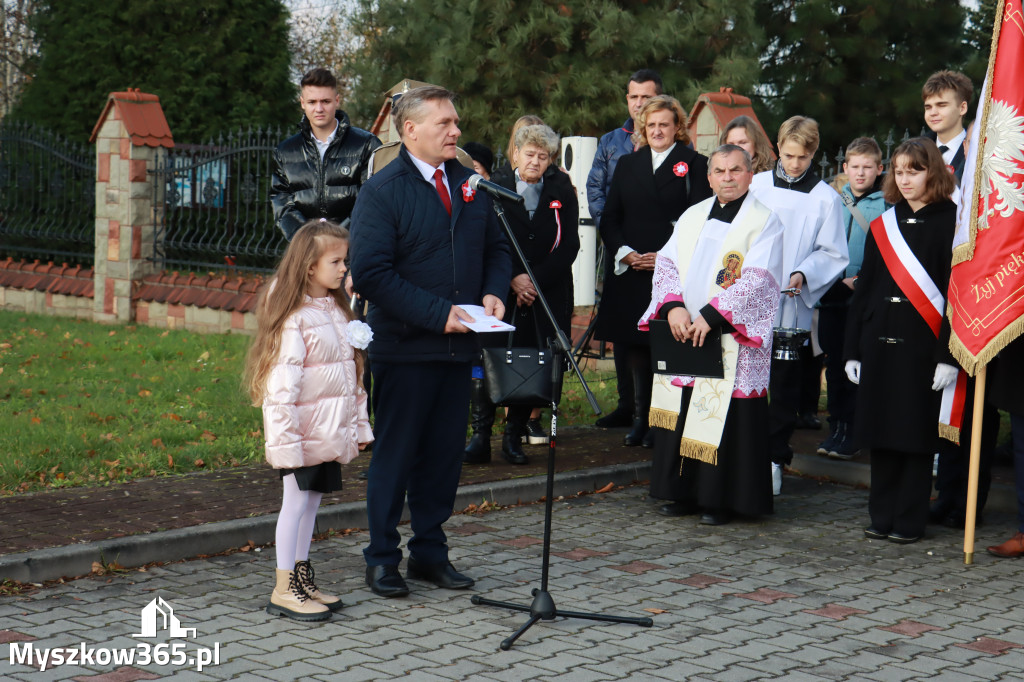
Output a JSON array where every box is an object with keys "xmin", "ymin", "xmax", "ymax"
[{"xmin": 270, "ymin": 110, "xmax": 381, "ymax": 241}]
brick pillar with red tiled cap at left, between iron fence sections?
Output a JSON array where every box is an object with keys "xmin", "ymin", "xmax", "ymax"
[{"xmin": 92, "ymin": 90, "xmax": 173, "ymax": 322}]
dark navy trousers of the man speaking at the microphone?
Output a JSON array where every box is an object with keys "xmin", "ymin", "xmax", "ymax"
[{"xmin": 362, "ymin": 361, "xmax": 471, "ymax": 566}]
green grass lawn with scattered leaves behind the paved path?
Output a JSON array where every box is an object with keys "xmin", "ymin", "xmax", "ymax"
[{"xmin": 0, "ymin": 311, "xmax": 615, "ymax": 496}]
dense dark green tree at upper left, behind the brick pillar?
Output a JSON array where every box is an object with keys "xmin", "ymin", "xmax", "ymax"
[{"xmin": 12, "ymin": 0, "xmax": 298, "ymax": 142}]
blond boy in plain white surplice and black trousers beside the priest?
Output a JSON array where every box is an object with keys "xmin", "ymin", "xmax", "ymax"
[{"xmin": 751, "ymin": 116, "xmax": 850, "ymax": 495}]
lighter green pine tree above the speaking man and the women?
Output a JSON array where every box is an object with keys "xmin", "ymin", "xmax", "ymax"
[{"xmin": 348, "ymin": 0, "xmax": 760, "ymax": 146}]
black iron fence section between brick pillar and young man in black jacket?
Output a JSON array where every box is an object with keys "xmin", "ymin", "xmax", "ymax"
[{"xmin": 150, "ymin": 128, "xmax": 287, "ymax": 272}]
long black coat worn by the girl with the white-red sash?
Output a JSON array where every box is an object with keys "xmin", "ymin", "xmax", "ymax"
[{"xmin": 844, "ymin": 201, "xmax": 956, "ymax": 454}]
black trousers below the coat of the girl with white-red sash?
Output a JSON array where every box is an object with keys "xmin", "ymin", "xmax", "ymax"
[{"xmin": 867, "ymin": 449, "xmax": 935, "ymax": 538}]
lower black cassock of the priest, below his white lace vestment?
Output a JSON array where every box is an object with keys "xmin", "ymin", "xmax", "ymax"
[{"xmin": 650, "ymin": 388, "xmax": 773, "ymax": 516}]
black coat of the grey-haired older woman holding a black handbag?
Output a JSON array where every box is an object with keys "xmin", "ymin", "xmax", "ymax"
[{"xmin": 490, "ymin": 166, "xmax": 580, "ymax": 346}]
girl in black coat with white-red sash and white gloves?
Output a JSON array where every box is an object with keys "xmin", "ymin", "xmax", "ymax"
[{"xmin": 845, "ymin": 137, "xmax": 958, "ymax": 544}]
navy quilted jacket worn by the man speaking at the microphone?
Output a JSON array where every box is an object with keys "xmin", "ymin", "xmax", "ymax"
[{"xmin": 350, "ymin": 145, "xmax": 511, "ymax": 364}]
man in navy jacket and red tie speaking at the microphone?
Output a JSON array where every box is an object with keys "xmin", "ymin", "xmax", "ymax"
[{"xmin": 351, "ymin": 86, "xmax": 511, "ymax": 597}]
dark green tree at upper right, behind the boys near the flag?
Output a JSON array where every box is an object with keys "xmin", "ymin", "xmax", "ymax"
[{"xmin": 756, "ymin": 0, "xmax": 980, "ymax": 161}]
